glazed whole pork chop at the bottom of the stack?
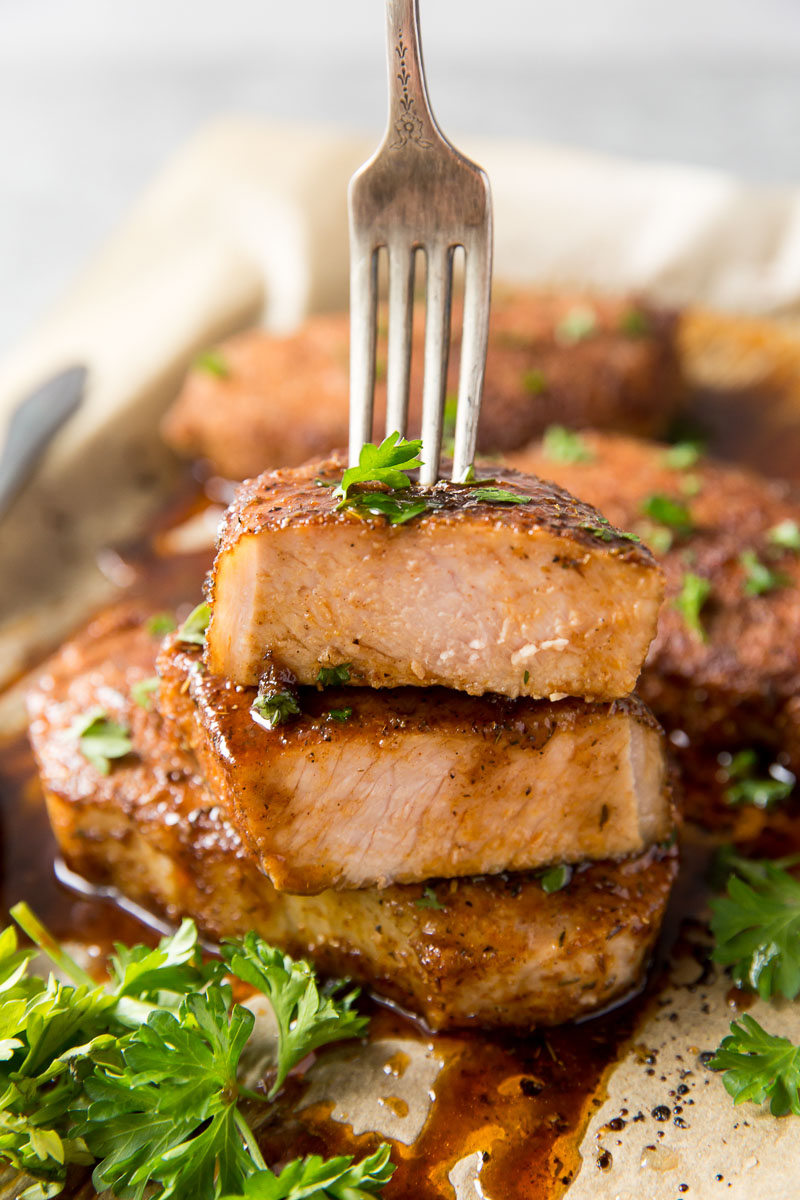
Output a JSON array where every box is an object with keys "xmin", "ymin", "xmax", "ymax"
[{"xmin": 30, "ymin": 612, "xmax": 676, "ymax": 1028}]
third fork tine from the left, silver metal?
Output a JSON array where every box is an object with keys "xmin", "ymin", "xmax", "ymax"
[{"xmin": 420, "ymin": 244, "xmax": 453, "ymax": 485}]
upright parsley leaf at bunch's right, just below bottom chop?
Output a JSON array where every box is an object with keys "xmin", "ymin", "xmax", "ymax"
[{"xmin": 222, "ymin": 932, "xmax": 367, "ymax": 1099}]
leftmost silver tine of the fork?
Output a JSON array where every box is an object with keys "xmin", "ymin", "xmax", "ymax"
[{"xmin": 349, "ymin": 235, "xmax": 378, "ymax": 467}]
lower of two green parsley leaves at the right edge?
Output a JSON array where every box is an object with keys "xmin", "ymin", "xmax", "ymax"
[{"xmin": 709, "ymin": 1013, "xmax": 800, "ymax": 1117}]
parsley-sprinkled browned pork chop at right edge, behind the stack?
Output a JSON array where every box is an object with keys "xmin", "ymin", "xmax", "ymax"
[{"xmin": 510, "ymin": 433, "xmax": 800, "ymax": 773}]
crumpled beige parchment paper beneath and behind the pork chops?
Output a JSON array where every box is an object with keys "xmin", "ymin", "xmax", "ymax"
[{"xmin": 0, "ymin": 121, "xmax": 800, "ymax": 1200}]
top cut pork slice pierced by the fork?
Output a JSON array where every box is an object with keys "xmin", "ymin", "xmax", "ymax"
[{"xmin": 206, "ymin": 456, "xmax": 662, "ymax": 700}]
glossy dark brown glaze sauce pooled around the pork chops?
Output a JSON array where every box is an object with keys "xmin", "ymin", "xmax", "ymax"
[{"xmin": 0, "ymin": 374, "xmax": 800, "ymax": 1200}]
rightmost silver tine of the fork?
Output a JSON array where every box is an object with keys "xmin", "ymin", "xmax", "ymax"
[{"xmin": 452, "ymin": 236, "xmax": 492, "ymax": 481}]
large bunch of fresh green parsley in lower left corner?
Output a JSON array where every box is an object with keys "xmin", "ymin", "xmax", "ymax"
[{"xmin": 0, "ymin": 905, "xmax": 392, "ymax": 1200}]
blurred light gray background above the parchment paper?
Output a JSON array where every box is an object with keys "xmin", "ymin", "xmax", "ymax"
[{"xmin": 0, "ymin": 0, "xmax": 800, "ymax": 353}]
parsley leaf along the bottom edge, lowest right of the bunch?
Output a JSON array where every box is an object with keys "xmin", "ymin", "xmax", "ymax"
[{"xmin": 222, "ymin": 1146, "xmax": 395, "ymax": 1200}]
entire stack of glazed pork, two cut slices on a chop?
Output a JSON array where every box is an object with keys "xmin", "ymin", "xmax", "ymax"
[{"xmin": 31, "ymin": 457, "xmax": 675, "ymax": 1028}]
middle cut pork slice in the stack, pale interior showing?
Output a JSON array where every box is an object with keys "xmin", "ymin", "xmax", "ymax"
[{"xmin": 158, "ymin": 638, "xmax": 672, "ymax": 893}]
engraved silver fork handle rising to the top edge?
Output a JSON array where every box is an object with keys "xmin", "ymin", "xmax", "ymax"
[{"xmin": 386, "ymin": 0, "xmax": 441, "ymax": 150}]
